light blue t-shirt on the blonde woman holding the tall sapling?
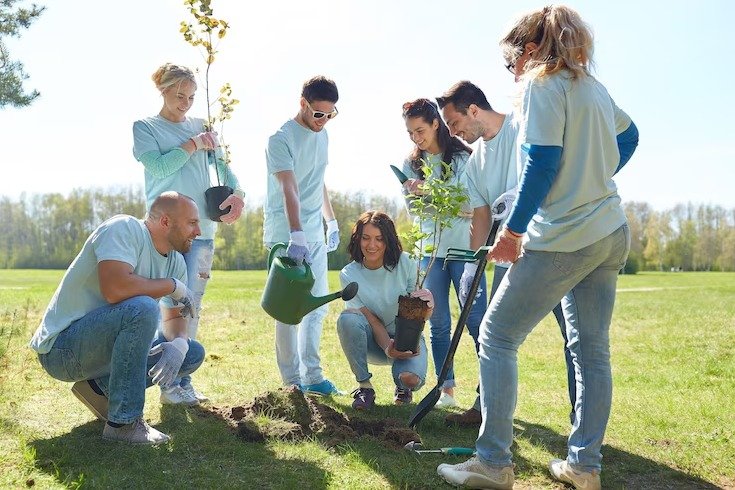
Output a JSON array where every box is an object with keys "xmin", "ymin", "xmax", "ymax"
[{"xmin": 133, "ymin": 115, "xmax": 238, "ymax": 240}]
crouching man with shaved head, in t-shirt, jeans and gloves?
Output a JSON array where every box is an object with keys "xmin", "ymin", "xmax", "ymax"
[{"xmin": 30, "ymin": 192, "xmax": 204, "ymax": 444}]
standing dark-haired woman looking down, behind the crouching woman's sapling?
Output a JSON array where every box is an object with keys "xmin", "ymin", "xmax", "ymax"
[{"xmin": 403, "ymin": 99, "xmax": 487, "ymax": 407}]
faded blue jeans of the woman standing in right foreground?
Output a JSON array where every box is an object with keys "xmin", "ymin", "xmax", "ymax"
[{"xmin": 477, "ymin": 225, "xmax": 630, "ymax": 471}]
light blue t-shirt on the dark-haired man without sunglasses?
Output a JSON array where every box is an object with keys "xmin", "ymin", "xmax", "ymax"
[{"xmin": 467, "ymin": 115, "xmax": 521, "ymax": 214}]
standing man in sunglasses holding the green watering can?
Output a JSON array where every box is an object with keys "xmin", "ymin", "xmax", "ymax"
[{"xmin": 263, "ymin": 76, "xmax": 340, "ymax": 395}]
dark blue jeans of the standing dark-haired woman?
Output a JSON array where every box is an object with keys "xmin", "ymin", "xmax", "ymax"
[{"xmin": 421, "ymin": 257, "xmax": 487, "ymax": 388}]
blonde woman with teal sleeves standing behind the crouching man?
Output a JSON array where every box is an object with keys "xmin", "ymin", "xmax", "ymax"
[{"xmin": 133, "ymin": 63, "xmax": 245, "ymax": 405}]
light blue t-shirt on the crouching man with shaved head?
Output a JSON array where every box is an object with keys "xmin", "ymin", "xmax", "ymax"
[{"xmin": 30, "ymin": 214, "xmax": 186, "ymax": 354}]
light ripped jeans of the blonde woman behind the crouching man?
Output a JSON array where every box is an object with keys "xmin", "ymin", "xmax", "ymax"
[{"xmin": 178, "ymin": 239, "xmax": 214, "ymax": 386}]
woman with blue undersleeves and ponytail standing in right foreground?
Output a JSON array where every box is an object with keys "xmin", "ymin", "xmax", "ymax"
[{"xmin": 437, "ymin": 6, "xmax": 638, "ymax": 490}]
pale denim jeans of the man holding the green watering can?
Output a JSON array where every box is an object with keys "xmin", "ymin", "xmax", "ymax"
[{"xmin": 266, "ymin": 242, "xmax": 329, "ymax": 386}]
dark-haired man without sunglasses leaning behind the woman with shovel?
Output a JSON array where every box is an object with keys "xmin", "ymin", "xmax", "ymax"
[{"xmin": 437, "ymin": 80, "xmax": 575, "ymax": 427}]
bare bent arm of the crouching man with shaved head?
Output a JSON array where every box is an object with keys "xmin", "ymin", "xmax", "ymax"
[{"xmin": 97, "ymin": 260, "xmax": 175, "ymax": 304}]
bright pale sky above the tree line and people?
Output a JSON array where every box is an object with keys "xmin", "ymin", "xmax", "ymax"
[{"xmin": 0, "ymin": 0, "xmax": 735, "ymax": 209}]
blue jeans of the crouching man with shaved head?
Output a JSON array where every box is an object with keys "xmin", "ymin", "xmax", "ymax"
[{"xmin": 38, "ymin": 296, "xmax": 204, "ymax": 424}]
